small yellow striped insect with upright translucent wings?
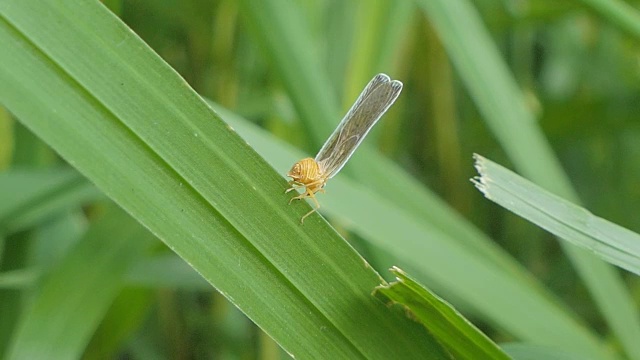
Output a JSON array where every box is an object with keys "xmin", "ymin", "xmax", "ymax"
[{"xmin": 285, "ymin": 74, "xmax": 402, "ymax": 224}]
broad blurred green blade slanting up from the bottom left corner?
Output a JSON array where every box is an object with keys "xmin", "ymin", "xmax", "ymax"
[{"xmin": 7, "ymin": 208, "xmax": 153, "ymax": 359}]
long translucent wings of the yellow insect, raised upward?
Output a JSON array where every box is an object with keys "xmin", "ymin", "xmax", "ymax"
[{"xmin": 315, "ymin": 74, "xmax": 402, "ymax": 178}]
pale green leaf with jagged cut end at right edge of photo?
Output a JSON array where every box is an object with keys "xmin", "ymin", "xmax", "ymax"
[{"xmin": 474, "ymin": 155, "xmax": 640, "ymax": 275}]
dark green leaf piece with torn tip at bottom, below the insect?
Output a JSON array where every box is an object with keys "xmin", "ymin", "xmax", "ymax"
[{"xmin": 376, "ymin": 268, "xmax": 509, "ymax": 359}]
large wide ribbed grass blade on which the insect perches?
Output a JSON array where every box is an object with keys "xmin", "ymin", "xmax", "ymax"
[{"xmin": 0, "ymin": 0, "xmax": 444, "ymax": 359}]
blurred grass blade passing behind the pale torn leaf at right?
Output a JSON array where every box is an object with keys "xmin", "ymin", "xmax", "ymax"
[{"xmin": 419, "ymin": 0, "xmax": 640, "ymax": 357}]
